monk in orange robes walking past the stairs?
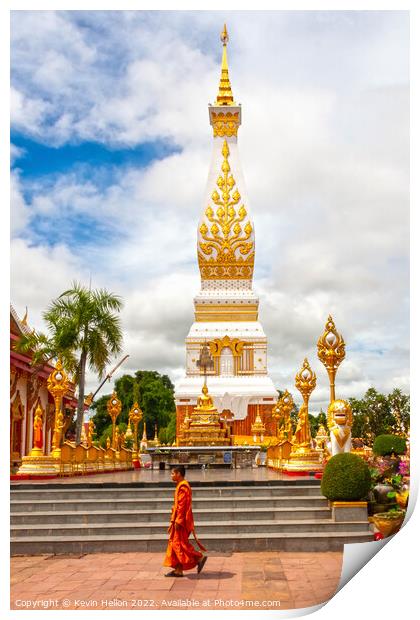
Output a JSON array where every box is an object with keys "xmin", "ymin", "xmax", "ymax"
[{"xmin": 163, "ymin": 465, "xmax": 207, "ymax": 577}]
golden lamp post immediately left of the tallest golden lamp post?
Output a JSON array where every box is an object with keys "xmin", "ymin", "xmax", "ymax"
[{"xmin": 284, "ymin": 358, "xmax": 322, "ymax": 473}]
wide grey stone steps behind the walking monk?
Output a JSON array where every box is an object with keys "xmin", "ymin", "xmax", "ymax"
[{"xmin": 10, "ymin": 480, "xmax": 373, "ymax": 555}]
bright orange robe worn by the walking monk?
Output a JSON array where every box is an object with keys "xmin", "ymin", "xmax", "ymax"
[{"xmin": 163, "ymin": 480, "xmax": 203, "ymax": 570}]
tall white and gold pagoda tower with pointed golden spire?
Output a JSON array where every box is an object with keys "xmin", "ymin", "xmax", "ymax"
[{"xmin": 175, "ymin": 25, "xmax": 278, "ymax": 444}]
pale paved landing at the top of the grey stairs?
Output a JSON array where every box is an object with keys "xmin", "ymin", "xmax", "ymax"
[{"xmin": 10, "ymin": 467, "xmax": 313, "ymax": 487}]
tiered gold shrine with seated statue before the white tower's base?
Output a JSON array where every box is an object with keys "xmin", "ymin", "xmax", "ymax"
[{"xmin": 178, "ymin": 384, "xmax": 231, "ymax": 446}]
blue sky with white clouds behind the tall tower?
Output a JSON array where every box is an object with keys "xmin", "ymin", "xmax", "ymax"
[{"xmin": 11, "ymin": 11, "xmax": 409, "ymax": 406}]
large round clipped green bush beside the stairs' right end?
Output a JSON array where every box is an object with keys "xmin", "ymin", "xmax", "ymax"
[{"xmin": 321, "ymin": 452, "xmax": 371, "ymax": 501}]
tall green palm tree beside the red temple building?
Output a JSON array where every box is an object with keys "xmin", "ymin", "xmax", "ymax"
[{"xmin": 16, "ymin": 282, "xmax": 123, "ymax": 444}]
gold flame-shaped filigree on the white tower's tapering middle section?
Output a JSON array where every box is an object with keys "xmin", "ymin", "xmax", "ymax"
[{"xmin": 198, "ymin": 140, "xmax": 255, "ymax": 280}]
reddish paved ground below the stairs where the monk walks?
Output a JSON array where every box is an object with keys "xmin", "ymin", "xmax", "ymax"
[{"xmin": 11, "ymin": 552, "xmax": 342, "ymax": 610}]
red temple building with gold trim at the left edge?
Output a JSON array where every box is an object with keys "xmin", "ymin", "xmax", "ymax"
[{"xmin": 10, "ymin": 306, "xmax": 77, "ymax": 473}]
